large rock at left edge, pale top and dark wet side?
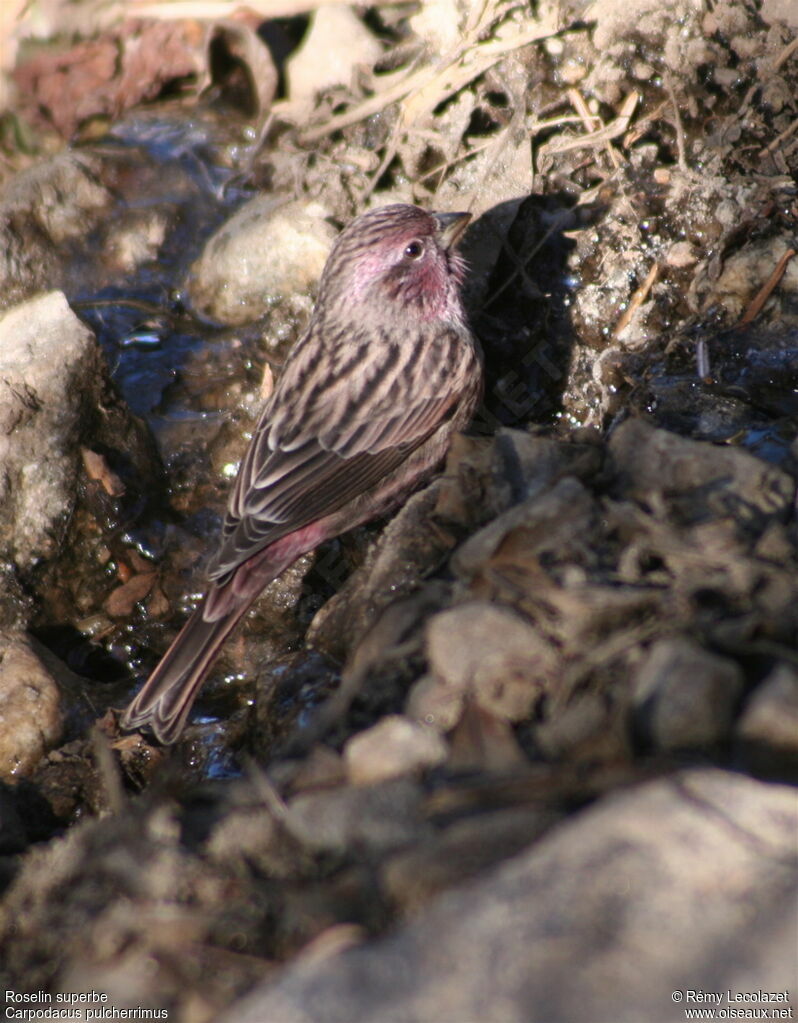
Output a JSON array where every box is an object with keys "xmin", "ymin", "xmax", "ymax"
[{"xmin": 0, "ymin": 292, "xmax": 162, "ymax": 627}]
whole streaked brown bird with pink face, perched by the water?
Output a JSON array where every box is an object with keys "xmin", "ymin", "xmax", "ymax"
[{"xmin": 122, "ymin": 205, "xmax": 482, "ymax": 743}]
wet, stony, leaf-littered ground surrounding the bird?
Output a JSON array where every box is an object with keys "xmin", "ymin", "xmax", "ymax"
[{"xmin": 0, "ymin": 0, "xmax": 798, "ymax": 1023}]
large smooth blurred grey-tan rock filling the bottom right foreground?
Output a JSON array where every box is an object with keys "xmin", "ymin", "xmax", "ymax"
[{"xmin": 221, "ymin": 769, "xmax": 798, "ymax": 1023}]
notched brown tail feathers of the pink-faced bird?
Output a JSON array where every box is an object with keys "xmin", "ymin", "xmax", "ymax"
[{"xmin": 120, "ymin": 591, "xmax": 257, "ymax": 744}]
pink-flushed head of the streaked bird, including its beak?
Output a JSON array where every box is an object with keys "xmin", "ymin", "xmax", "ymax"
[{"xmin": 319, "ymin": 206, "xmax": 471, "ymax": 323}]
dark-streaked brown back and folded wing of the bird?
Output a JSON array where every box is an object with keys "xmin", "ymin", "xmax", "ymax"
[{"xmin": 209, "ymin": 329, "xmax": 472, "ymax": 580}]
